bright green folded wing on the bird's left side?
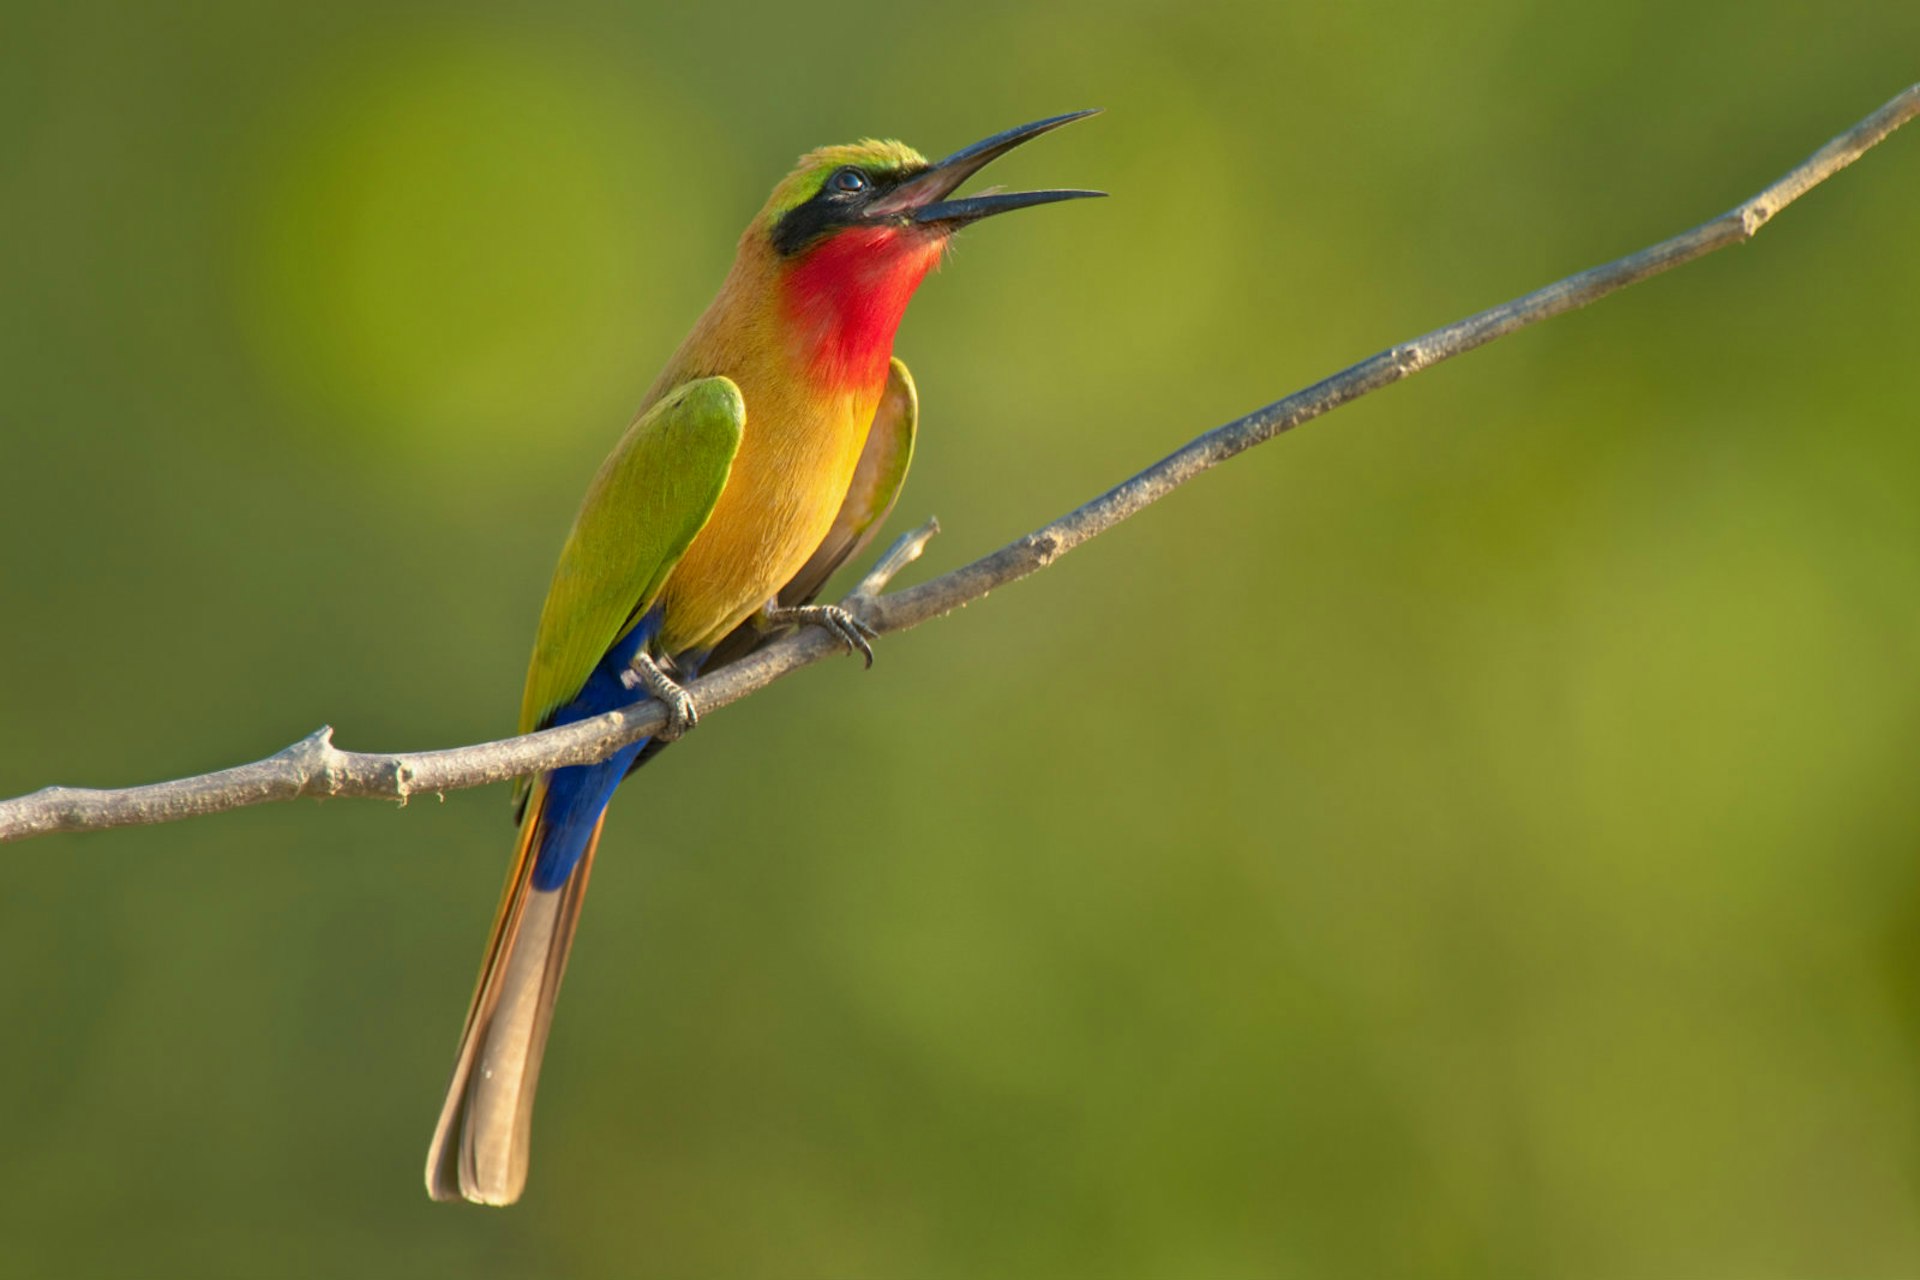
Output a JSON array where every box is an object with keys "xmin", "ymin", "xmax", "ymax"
[{"xmin": 520, "ymin": 378, "xmax": 747, "ymax": 733}]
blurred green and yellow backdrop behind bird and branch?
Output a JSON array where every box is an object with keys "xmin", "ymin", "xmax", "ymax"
[{"xmin": 0, "ymin": 0, "xmax": 1920, "ymax": 1280}]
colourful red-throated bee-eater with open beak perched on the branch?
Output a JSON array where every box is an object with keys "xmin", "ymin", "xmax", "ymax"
[{"xmin": 426, "ymin": 111, "xmax": 1104, "ymax": 1205}]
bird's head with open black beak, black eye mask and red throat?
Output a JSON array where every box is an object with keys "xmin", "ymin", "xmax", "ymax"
[{"xmin": 743, "ymin": 111, "xmax": 1104, "ymax": 386}]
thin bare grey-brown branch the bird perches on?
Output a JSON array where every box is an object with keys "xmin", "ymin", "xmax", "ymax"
[{"xmin": 0, "ymin": 84, "xmax": 1920, "ymax": 841}]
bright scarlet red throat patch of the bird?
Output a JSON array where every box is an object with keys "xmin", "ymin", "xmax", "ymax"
[{"xmin": 783, "ymin": 226, "xmax": 947, "ymax": 391}]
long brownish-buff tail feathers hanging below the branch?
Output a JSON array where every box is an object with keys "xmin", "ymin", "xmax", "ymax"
[{"xmin": 426, "ymin": 781, "xmax": 605, "ymax": 1205}]
